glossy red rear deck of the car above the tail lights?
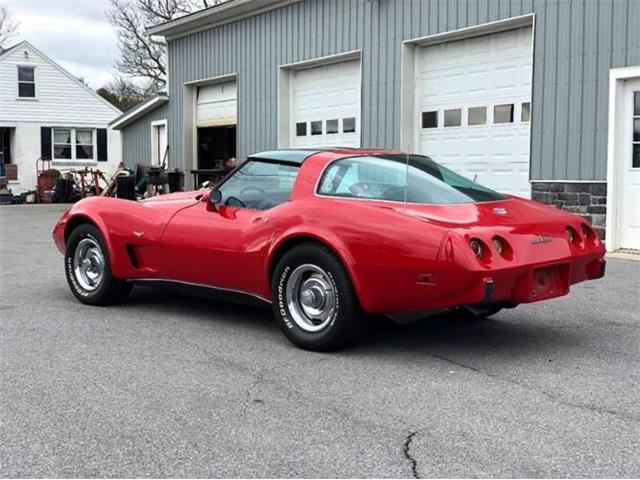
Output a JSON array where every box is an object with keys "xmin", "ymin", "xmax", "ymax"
[{"xmin": 401, "ymin": 197, "xmax": 570, "ymax": 227}]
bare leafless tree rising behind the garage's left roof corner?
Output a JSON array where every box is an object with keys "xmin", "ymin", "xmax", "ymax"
[{"xmin": 109, "ymin": 0, "xmax": 212, "ymax": 91}]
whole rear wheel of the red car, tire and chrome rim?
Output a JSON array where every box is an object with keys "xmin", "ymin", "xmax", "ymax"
[{"xmin": 272, "ymin": 243, "xmax": 364, "ymax": 351}]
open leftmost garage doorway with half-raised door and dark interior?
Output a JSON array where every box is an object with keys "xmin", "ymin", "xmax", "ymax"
[{"xmin": 193, "ymin": 80, "xmax": 238, "ymax": 187}]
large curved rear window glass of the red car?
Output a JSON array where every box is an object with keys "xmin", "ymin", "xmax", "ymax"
[{"xmin": 318, "ymin": 155, "xmax": 507, "ymax": 204}]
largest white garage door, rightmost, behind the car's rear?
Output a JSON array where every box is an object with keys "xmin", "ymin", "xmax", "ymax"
[{"xmin": 416, "ymin": 27, "xmax": 532, "ymax": 197}]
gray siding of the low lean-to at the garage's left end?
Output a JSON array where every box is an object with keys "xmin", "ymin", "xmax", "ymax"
[{"xmin": 122, "ymin": 103, "xmax": 169, "ymax": 167}]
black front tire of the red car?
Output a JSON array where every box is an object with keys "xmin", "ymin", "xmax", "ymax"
[{"xmin": 64, "ymin": 223, "xmax": 131, "ymax": 305}]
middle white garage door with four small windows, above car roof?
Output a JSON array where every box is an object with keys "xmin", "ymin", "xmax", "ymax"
[{"xmin": 289, "ymin": 60, "xmax": 360, "ymax": 148}]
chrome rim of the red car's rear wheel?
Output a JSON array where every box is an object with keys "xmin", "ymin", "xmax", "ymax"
[{"xmin": 285, "ymin": 264, "xmax": 336, "ymax": 333}]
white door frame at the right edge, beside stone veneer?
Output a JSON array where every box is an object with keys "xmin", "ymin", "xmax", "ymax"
[{"xmin": 605, "ymin": 66, "xmax": 640, "ymax": 252}]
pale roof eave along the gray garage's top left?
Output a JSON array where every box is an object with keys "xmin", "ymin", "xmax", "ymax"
[{"xmin": 147, "ymin": 0, "xmax": 300, "ymax": 39}]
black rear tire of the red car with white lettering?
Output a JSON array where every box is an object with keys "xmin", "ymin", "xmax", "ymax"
[{"xmin": 271, "ymin": 243, "xmax": 365, "ymax": 351}]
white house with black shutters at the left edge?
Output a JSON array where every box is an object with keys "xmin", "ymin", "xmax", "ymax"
[{"xmin": 0, "ymin": 41, "xmax": 121, "ymax": 189}]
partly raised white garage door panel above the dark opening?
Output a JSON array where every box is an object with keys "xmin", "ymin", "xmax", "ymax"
[{"xmin": 196, "ymin": 81, "xmax": 238, "ymax": 127}]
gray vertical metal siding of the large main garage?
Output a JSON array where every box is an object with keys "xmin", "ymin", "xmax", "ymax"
[{"xmin": 159, "ymin": 0, "xmax": 640, "ymax": 180}]
